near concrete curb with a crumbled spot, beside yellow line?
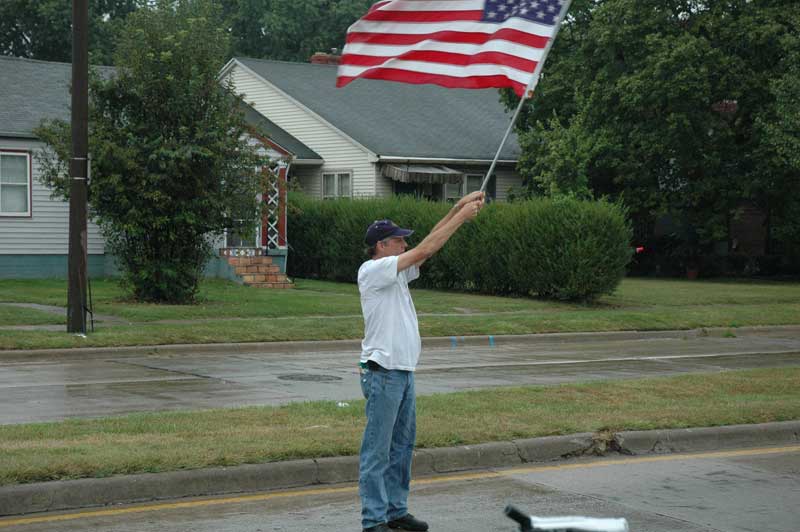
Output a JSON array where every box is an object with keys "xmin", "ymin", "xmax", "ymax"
[{"xmin": 0, "ymin": 421, "xmax": 800, "ymax": 516}]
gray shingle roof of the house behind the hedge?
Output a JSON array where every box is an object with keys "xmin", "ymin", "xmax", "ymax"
[{"xmin": 236, "ymin": 58, "xmax": 520, "ymax": 160}]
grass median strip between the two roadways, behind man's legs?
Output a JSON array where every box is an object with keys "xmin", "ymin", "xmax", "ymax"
[{"xmin": 0, "ymin": 368, "xmax": 800, "ymax": 485}]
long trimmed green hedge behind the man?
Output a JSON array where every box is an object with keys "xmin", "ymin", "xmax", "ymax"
[{"xmin": 288, "ymin": 193, "xmax": 631, "ymax": 301}]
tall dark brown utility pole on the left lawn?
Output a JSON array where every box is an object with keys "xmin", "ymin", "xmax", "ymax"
[{"xmin": 67, "ymin": 0, "xmax": 89, "ymax": 334}]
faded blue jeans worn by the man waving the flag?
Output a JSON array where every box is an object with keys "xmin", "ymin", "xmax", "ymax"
[{"xmin": 358, "ymin": 369, "xmax": 417, "ymax": 528}]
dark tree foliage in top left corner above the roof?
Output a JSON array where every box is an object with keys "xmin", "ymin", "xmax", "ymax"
[{"xmin": 0, "ymin": 0, "xmax": 141, "ymax": 64}]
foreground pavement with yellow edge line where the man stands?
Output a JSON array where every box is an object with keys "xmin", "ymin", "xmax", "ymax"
[{"xmin": 0, "ymin": 446, "xmax": 800, "ymax": 532}]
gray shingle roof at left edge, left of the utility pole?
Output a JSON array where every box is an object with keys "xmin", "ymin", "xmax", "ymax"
[{"xmin": 0, "ymin": 56, "xmax": 72, "ymax": 138}]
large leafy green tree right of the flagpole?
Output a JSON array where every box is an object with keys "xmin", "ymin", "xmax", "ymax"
[{"xmin": 506, "ymin": 0, "xmax": 800, "ymax": 254}]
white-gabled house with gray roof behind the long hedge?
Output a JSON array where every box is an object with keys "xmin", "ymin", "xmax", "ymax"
[{"xmin": 220, "ymin": 54, "xmax": 522, "ymax": 200}]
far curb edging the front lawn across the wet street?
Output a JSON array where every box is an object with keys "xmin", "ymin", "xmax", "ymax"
[{"xmin": 0, "ymin": 325, "xmax": 800, "ymax": 360}]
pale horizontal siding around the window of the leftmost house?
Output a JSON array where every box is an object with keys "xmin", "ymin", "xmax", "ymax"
[{"xmin": 0, "ymin": 139, "xmax": 104, "ymax": 255}]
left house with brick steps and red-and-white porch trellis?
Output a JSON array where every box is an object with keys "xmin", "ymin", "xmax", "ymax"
[{"xmin": 0, "ymin": 56, "xmax": 304, "ymax": 283}]
